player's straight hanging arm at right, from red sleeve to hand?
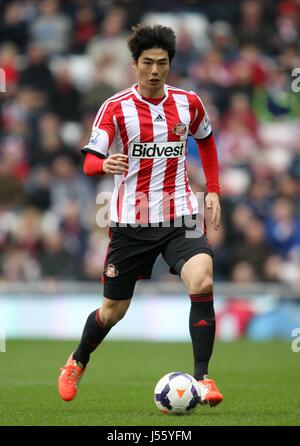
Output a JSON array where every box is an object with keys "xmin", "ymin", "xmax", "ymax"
[{"xmin": 190, "ymin": 94, "xmax": 221, "ymax": 230}]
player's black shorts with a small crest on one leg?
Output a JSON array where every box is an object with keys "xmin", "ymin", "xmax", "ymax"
[{"xmin": 102, "ymin": 216, "xmax": 213, "ymax": 300}]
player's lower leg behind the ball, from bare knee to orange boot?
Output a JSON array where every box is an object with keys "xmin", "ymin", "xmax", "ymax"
[{"xmin": 180, "ymin": 253, "xmax": 223, "ymax": 406}]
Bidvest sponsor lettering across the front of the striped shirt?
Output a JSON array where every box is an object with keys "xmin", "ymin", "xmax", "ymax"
[{"xmin": 130, "ymin": 141, "xmax": 186, "ymax": 158}]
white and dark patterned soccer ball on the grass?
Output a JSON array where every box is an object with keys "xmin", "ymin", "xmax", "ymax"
[{"xmin": 154, "ymin": 372, "xmax": 200, "ymax": 414}]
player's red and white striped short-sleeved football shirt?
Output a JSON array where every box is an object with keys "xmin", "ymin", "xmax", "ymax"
[{"xmin": 83, "ymin": 85, "xmax": 212, "ymax": 224}]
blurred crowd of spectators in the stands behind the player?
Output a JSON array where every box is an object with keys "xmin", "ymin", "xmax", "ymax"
[{"xmin": 0, "ymin": 0, "xmax": 300, "ymax": 286}]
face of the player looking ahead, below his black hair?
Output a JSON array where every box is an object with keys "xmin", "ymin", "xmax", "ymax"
[{"xmin": 133, "ymin": 48, "xmax": 170, "ymax": 96}]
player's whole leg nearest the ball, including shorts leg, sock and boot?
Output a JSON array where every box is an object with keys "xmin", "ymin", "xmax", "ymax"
[{"xmin": 163, "ymin": 220, "xmax": 223, "ymax": 405}]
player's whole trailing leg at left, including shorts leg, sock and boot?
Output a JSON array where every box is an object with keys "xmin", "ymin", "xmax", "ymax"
[{"xmin": 58, "ymin": 228, "xmax": 157, "ymax": 401}]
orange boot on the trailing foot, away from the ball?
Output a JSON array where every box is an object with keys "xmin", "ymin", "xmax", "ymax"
[{"xmin": 58, "ymin": 353, "xmax": 85, "ymax": 401}]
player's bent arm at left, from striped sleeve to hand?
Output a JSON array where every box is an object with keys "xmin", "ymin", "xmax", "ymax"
[{"xmin": 82, "ymin": 100, "xmax": 128, "ymax": 176}]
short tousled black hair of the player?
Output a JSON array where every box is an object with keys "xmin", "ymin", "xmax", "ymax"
[{"xmin": 128, "ymin": 25, "xmax": 176, "ymax": 64}]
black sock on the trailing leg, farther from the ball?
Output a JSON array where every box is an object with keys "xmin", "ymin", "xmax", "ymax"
[{"xmin": 73, "ymin": 309, "xmax": 110, "ymax": 367}]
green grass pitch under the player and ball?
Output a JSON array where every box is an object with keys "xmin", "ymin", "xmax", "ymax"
[{"xmin": 0, "ymin": 341, "xmax": 300, "ymax": 426}]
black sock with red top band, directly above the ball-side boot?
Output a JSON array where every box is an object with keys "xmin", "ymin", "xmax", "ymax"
[{"xmin": 190, "ymin": 293, "xmax": 216, "ymax": 381}]
